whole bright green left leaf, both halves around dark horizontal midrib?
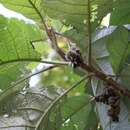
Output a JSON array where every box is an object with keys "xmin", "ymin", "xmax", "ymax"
[{"xmin": 0, "ymin": 16, "xmax": 41, "ymax": 89}]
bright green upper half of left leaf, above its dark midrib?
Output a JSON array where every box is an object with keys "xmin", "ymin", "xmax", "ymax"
[{"xmin": 0, "ymin": 16, "xmax": 41, "ymax": 63}]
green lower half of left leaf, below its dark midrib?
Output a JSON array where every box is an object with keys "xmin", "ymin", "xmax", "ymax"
[{"xmin": 0, "ymin": 63, "xmax": 29, "ymax": 90}]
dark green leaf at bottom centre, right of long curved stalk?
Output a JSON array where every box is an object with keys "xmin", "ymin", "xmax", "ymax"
[{"xmin": 39, "ymin": 95, "xmax": 95, "ymax": 130}]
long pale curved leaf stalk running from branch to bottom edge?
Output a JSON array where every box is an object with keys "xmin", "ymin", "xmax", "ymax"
[{"xmin": 35, "ymin": 76, "xmax": 88, "ymax": 130}]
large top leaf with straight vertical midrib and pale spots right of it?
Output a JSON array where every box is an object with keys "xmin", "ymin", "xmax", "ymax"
[{"xmin": 43, "ymin": 0, "xmax": 112, "ymax": 30}]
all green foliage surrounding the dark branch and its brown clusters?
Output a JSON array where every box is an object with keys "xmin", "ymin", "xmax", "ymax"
[{"xmin": 0, "ymin": 0, "xmax": 130, "ymax": 130}]
